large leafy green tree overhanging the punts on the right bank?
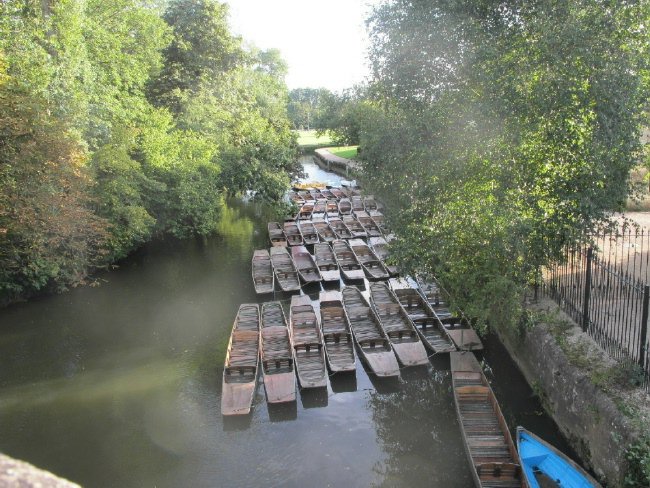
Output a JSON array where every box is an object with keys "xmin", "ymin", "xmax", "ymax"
[{"xmin": 360, "ymin": 0, "xmax": 648, "ymax": 326}]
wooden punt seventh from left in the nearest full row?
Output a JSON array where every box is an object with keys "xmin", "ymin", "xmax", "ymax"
[{"xmin": 388, "ymin": 278, "xmax": 456, "ymax": 354}]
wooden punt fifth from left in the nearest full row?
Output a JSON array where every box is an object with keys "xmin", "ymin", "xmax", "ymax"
[{"xmin": 341, "ymin": 286, "xmax": 399, "ymax": 378}]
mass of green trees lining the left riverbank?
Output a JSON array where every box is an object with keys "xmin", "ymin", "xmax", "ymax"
[{"xmin": 0, "ymin": 0, "xmax": 297, "ymax": 302}]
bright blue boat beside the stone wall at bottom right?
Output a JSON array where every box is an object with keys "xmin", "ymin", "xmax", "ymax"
[{"xmin": 517, "ymin": 427, "xmax": 602, "ymax": 488}]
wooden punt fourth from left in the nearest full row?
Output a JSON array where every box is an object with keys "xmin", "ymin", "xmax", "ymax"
[{"xmin": 319, "ymin": 291, "xmax": 357, "ymax": 373}]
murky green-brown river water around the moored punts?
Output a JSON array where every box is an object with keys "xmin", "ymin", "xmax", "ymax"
[{"xmin": 0, "ymin": 159, "xmax": 566, "ymax": 488}]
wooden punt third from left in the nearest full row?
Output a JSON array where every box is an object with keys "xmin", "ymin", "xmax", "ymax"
[{"xmin": 289, "ymin": 295, "xmax": 327, "ymax": 388}]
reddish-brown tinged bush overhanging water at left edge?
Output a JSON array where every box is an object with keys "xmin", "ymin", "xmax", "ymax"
[{"xmin": 0, "ymin": 62, "xmax": 104, "ymax": 301}]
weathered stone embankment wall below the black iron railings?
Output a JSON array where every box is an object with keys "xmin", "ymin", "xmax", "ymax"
[{"xmin": 497, "ymin": 298, "xmax": 650, "ymax": 487}]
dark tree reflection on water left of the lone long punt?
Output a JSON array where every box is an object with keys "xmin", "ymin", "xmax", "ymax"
[{"xmin": 368, "ymin": 370, "xmax": 472, "ymax": 488}]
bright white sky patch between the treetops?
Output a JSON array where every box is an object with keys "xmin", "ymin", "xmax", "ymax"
[{"xmin": 225, "ymin": 0, "xmax": 381, "ymax": 91}]
